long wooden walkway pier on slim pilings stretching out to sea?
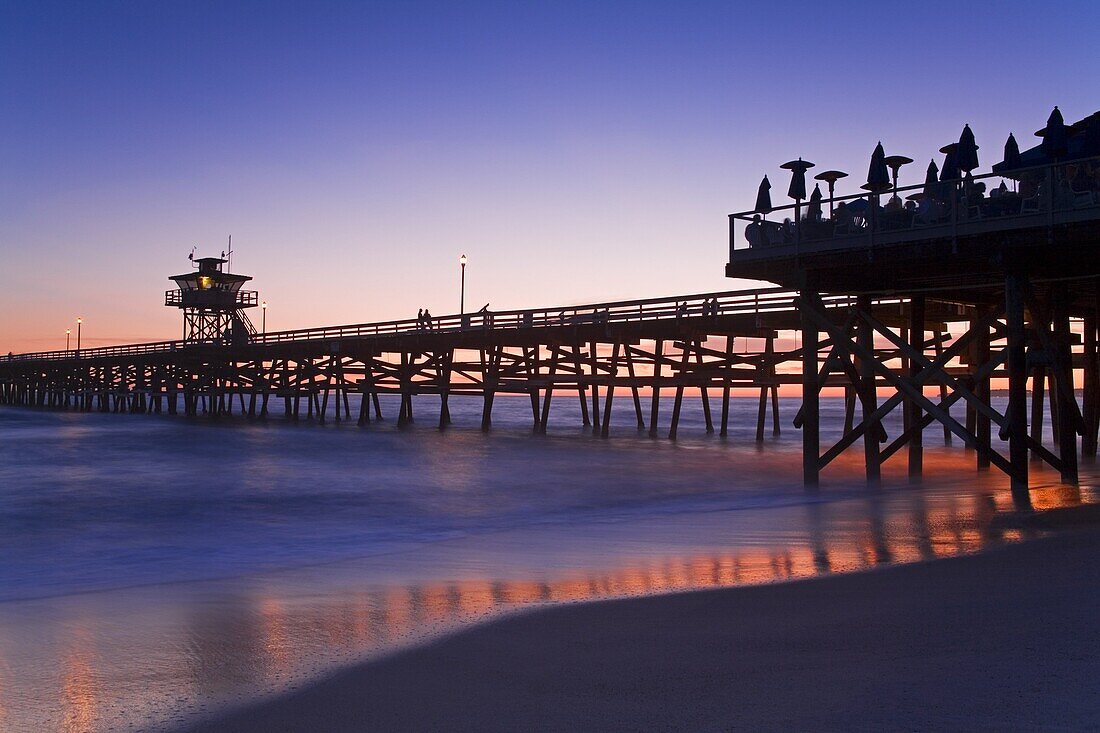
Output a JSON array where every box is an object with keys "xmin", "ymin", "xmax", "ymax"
[{"xmin": 0, "ymin": 288, "xmax": 968, "ymax": 439}]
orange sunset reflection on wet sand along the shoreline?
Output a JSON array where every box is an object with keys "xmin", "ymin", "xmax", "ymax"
[{"xmin": 0, "ymin": 479, "xmax": 1097, "ymax": 732}]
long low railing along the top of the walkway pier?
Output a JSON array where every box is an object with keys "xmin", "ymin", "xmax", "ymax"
[{"xmin": 2, "ymin": 287, "xmax": 875, "ymax": 361}]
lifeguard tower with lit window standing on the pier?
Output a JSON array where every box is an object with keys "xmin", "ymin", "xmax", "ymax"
[{"xmin": 164, "ymin": 258, "xmax": 259, "ymax": 346}]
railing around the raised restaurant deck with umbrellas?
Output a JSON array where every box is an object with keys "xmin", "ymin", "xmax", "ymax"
[{"xmin": 729, "ymin": 150, "xmax": 1100, "ymax": 262}]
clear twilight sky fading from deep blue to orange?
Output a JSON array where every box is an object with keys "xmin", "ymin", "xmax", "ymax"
[{"xmin": 0, "ymin": 0, "xmax": 1100, "ymax": 352}]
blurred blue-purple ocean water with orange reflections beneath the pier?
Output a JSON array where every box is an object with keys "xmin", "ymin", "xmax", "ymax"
[{"xmin": 0, "ymin": 395, "xmax": 1096, "ymax": 731}]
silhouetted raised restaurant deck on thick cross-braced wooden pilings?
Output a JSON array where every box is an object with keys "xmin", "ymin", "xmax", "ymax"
[{"xmin": 726, "ymin": 149, "xmax": 1100, "ymax": 502}]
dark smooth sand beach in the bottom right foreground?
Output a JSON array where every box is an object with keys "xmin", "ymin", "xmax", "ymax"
[{"xmin": 188, "ymin": 527, "xmax": 1100, "ymax": 733}]
